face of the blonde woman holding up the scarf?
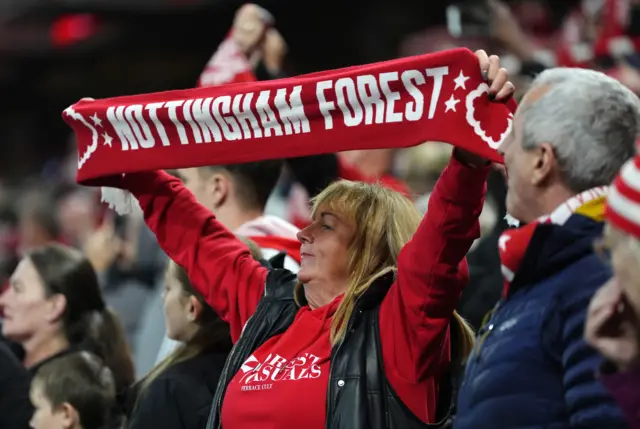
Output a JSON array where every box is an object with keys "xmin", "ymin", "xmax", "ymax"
[{"xmin": 298, "ymin": 208, "xmax": 355, "ymax": 286}]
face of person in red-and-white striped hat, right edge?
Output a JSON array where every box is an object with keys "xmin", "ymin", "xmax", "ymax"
[{"xmin": 604, "ymin": 225, "xmax": 640, "ymax": 312}]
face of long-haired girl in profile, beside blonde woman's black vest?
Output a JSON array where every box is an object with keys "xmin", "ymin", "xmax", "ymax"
[{"xmin": 162, "ymin": 276, "xmax": 197, "ymax": 342}]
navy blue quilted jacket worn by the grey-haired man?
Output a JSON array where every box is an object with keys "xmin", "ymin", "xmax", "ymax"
[{"xmin": 454, "ymin": 214, "xmax": 627, "ymax": 429}]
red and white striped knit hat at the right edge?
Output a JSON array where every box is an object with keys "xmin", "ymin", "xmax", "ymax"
[{"xmin": 605, "ymin": 154, "xmax": 640, "ymax": 238}]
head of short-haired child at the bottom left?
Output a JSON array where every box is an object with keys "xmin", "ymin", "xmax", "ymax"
[{"xmin": 30, "ymin": 352, "xmax": 115, "ymax": 429}]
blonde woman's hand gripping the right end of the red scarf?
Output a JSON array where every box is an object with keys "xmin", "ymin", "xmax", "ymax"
[{"xmin": 453, "ymin": 49, "xmax": 516, "ymax": 167}]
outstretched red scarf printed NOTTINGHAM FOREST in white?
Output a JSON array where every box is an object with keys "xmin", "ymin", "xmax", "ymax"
[{"xmin": 63, "ymin": 49, "xmax": 516, "ymax": 185}]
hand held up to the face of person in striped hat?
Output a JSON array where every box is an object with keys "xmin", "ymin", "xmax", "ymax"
[{"xmin": 585, "ymin": 277, "xmax": 640, "ymax": 371}]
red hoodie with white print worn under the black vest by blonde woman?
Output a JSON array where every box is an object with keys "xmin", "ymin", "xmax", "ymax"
[{"xmin": 123, "ymin": 155, "xmax": 488, "ymax": 429}]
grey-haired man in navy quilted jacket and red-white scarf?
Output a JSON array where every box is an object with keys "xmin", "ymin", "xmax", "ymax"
[{"xmin": 454, "ymin": 68, "xmax": 640, "ymax": 429}]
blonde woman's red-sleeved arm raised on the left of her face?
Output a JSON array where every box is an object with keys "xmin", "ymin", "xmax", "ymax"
[{"xmin": 121, "ymin": 171, "xmax": 267, "ymax": 341}]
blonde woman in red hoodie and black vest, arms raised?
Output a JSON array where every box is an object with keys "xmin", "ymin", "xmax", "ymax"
[{"xmin": 92, "ymin": 51, "xmax": 513, "ymax": 429}]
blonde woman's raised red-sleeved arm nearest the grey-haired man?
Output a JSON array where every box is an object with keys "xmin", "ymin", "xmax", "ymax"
[{"xmin": 380, "ymin": 157, "xmax": 490, "ymax": 382}]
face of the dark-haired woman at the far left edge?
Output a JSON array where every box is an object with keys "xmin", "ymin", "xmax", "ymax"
[{"xmin": 0, "ymin": 258, "xmax": 54, "ymax": 343}]
